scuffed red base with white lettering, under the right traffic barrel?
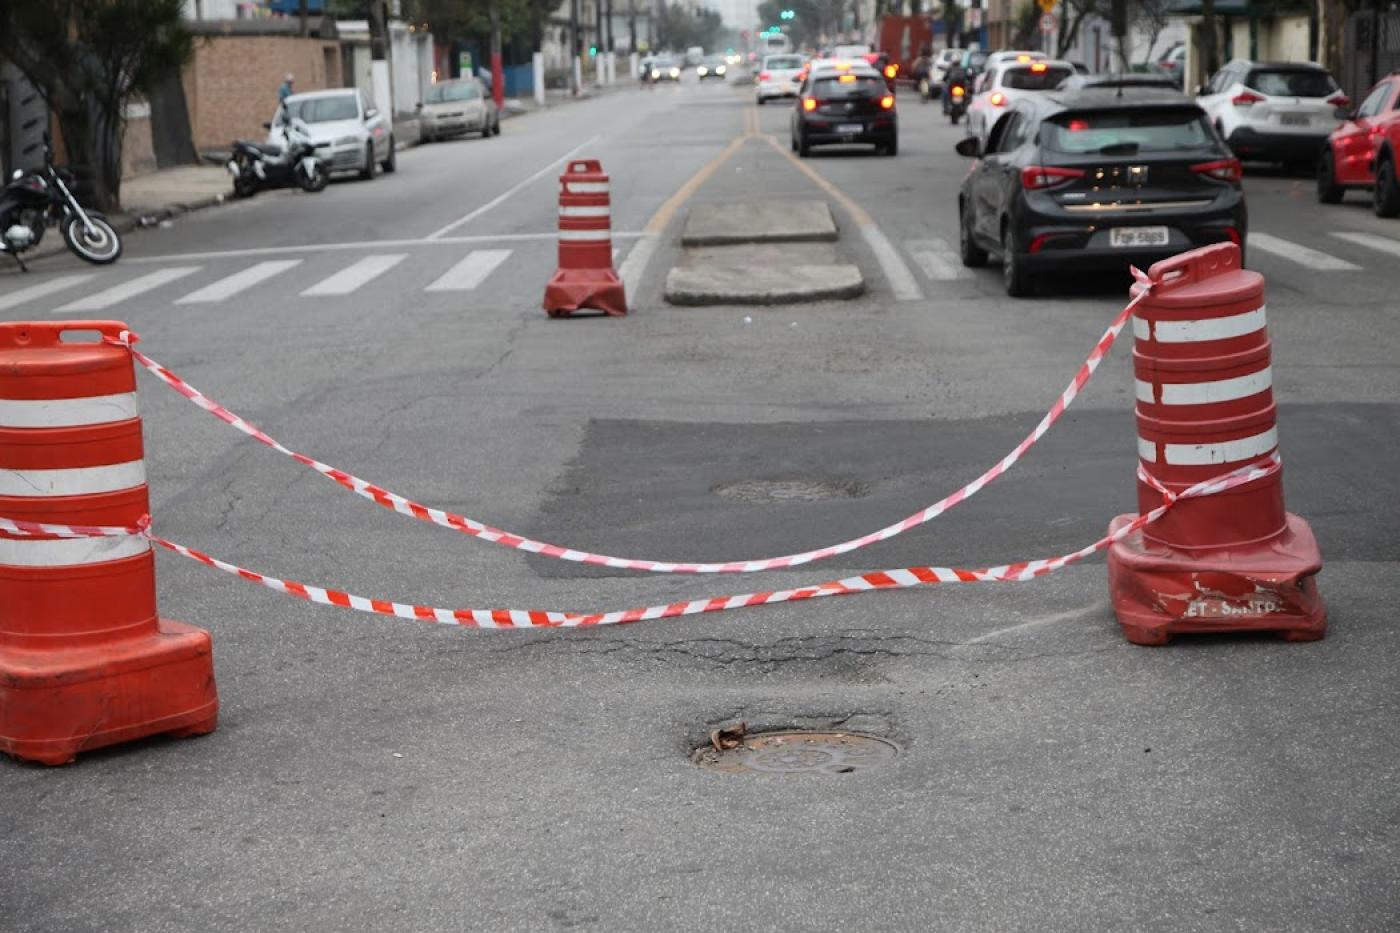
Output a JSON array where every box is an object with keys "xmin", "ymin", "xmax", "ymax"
[{"xmin": 1109, "ymin": 514, "xmax": 1327, "ymax": 644}]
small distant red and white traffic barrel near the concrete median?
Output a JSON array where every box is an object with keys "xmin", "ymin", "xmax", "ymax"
[{"xmin": 545, "ymin": 158, "xmax": 627, "ymax": 318}]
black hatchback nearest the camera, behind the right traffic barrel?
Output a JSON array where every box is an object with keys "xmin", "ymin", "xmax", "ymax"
[{"xmin": 956, "ymin": 90, "xmax": 1247, "ymax": 297}]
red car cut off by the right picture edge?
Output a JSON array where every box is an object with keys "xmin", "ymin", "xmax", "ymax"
[{"xmin": 1317, "ymin": 71, "xmax": 1400, "ymax": 217}]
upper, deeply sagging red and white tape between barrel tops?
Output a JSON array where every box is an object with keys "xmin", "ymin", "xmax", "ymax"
[{"xmin": 98, "ymin": 269, "xmax": 1151, "ymax": 573}]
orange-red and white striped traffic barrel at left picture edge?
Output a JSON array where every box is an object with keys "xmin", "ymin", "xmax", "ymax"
[{"xmin": 0, "ymin": 321, "xmax": 218, "ymax": 765}]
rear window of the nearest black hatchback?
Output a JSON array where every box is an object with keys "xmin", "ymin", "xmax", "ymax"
[{"xmin": 1040, "ymin": 108, "xmax": 1211, "ymax": 156}]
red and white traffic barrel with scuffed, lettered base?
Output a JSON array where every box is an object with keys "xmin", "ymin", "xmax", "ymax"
[{"xmin": 1109, "ymin": 244, "xmax": 1327, "ymax": 644}]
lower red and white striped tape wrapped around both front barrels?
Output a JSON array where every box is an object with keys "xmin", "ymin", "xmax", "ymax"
[{"xmin": 0, "ymin": 451, "xmax": 1282, "ymax": 629}]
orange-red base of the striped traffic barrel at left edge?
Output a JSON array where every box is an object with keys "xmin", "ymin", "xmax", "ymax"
[{"xmin": 0, "ymin": 619, "xmax": 218, "ymax": 765}]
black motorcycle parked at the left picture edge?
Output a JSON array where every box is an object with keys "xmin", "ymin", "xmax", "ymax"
[{"xmin": 0, "ymin": 133, "xmax": 122, "ymax": 272}]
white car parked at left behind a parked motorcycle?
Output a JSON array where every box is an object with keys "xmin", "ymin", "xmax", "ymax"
[{"xmin": 267, "ymin": 87, "xmax": 398, "ymax": 181}]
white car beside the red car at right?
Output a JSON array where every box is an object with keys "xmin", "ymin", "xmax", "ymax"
[{"xmin": 1196, "ymin": 62, "xmax": 1350, "ymax": 165}]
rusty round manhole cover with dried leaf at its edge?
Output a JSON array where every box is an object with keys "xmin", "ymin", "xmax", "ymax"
[{"xmin": 693, "ymin": 731, "xmax": 899, "ymax": 775}]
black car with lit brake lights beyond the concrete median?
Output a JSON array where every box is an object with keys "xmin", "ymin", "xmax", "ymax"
[{"xmin": 791, "ymin": 62, "xmax": 899, "ymax": 158}]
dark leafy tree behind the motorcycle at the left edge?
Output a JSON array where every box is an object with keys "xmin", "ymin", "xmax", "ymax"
[{"xmin": 0, "ymin": 0, "xmax": 193, "ymax": 210}]
